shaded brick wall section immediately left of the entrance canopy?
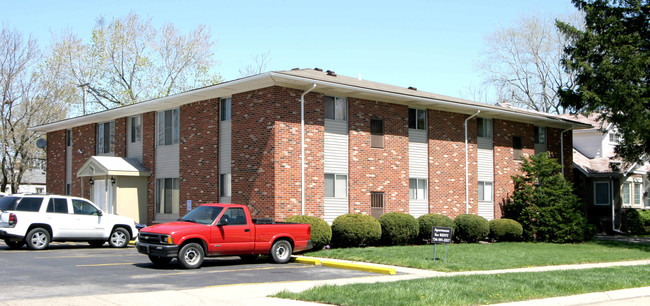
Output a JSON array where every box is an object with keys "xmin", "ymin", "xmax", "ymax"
[{"xmin": 72, "ymin": 123, "xmax": 97, "ymax": 198}]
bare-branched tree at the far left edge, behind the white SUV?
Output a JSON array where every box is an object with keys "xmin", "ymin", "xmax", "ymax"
[{"xmin": 0, "ymin": 26, "xmax": 69, "ymax": 192}]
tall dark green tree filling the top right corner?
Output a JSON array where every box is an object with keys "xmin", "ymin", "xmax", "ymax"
[{"xmin": 557, "ymin": 0, "xmax": 650, "ymax": 162}]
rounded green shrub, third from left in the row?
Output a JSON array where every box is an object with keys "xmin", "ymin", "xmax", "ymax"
[{"xmin": 379, "ymin": 212, "xmax": 418, "ymax": 245}]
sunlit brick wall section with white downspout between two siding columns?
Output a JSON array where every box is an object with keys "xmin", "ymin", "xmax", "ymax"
[{"xmin": 428, "ymin": 110, "xmax": 478, "ymax": 218}]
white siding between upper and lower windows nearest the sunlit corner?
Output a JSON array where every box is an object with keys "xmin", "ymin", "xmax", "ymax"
[{"xmin": 324, "ymin": 120, "xmax": 348, "ymax": 174}]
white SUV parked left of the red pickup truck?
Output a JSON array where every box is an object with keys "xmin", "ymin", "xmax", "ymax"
[{"xmin": 0, "ymin": 194, "xmax": 138, "ymax": 250}]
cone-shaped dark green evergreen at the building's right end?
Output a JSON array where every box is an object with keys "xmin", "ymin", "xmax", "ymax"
[{"xmin": 503, "ymin": 153, "xmax": 589, "ymax": 243}]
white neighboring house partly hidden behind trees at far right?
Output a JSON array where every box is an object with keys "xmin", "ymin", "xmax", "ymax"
[{"xmin": 564, "ymin": 114, "xmax": 650, "ymax": 230}]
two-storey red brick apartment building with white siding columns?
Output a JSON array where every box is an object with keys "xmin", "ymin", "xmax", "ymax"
[{"xmin": 33, "ymin": 69, "xmax": 589, "ymax": 224}]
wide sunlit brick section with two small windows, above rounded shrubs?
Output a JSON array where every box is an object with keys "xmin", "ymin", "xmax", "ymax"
[{"xmin": 348, "ymin": 98, "xmax": 409, "ymax": 214}]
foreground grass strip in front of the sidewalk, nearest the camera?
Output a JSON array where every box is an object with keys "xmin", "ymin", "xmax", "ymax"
[{"xmin": 276, "ymin": 265, "xmax": 650, "ymax": 305}]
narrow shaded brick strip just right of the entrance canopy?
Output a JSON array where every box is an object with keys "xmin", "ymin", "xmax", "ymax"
[{"xmin": 142, "ymin": 112, "xmax": 156, "ymax": 224}]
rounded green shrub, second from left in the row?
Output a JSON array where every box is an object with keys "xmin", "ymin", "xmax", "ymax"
[{"xmin": 332, "ymin": 214, "xmax": 381, "ymax": 247}]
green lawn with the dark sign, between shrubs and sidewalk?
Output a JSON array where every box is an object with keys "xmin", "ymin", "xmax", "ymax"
[{"xmin": 305, "ymin": 241, "xmax": 650, "ymax": 272}]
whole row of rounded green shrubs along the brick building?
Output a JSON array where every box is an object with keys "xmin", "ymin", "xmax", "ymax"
[{"xmin": 286, "ymin": 212, "xmax": 523, "ymax": 250}]
